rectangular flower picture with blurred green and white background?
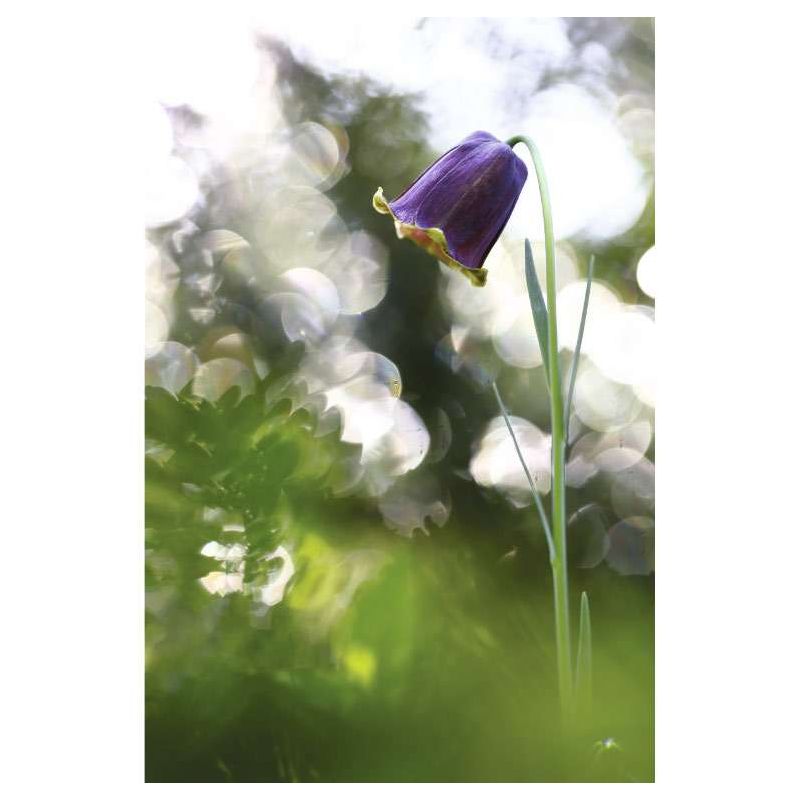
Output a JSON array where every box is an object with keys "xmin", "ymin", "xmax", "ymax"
[{"xmin": 143, "ymin": 15, "xmax": 657, "ymax": 783}]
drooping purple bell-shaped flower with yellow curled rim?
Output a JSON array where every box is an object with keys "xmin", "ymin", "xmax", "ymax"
[{"xmin": 372, "ymin": 131, "xmax": 528, "ymax": 286}]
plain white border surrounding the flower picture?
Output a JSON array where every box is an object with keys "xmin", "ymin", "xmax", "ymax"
[{"xmin": 9, "ymin": 2, "xmax": 800, "ymax": 797}]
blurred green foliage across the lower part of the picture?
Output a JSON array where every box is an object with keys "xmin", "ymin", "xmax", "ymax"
[{"xmin": 146, "ymin": 380, "xmax": 653, "ymax": 781}]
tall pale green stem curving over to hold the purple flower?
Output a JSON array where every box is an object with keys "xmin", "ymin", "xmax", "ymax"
[{"xmin": 506, "ymin": 136, "xmax": 573, "ymax": 715}]
